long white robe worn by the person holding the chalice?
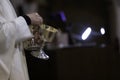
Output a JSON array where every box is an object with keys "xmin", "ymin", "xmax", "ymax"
[{"xmin": 0, "ymin": 0, "xmax": 32, "ymax": 80}]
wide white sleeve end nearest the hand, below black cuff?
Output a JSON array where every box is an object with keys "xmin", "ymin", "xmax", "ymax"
[{"xmin": 15, "ymin": 17, "xmax": 33, "ymax": 42}]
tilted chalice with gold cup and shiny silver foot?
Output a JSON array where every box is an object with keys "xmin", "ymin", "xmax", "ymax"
[{"xmin": 31, "ymin": 24, "xmax": 58, "ymax": 60}]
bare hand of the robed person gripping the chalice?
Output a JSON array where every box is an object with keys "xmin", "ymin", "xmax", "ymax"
[{"xmin": 27, "ymin": 12, "xmax": 43, "ymax": 26}]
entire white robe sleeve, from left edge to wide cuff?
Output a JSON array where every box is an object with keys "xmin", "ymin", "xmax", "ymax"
[{"xmin": 0, "ymin": 17, "xmax": 33, "ymax": 51}]
